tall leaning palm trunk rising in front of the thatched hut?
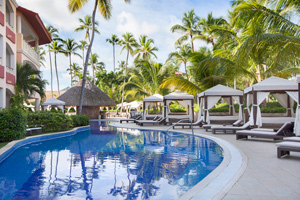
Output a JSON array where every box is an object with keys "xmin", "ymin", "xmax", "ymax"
[{"xmin": 79, "ymin": 0, "xmax": 98, "ymax": 114}]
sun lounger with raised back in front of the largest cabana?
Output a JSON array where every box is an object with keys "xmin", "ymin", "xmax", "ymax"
[{"xmin": 236, "ymin": 122, "xmax": 293, "ymax": 140}]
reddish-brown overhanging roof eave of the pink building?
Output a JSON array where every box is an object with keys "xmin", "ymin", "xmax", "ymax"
[{"xmin": 17, "ymin": 6, "xmax": 52, "ymax": 45}]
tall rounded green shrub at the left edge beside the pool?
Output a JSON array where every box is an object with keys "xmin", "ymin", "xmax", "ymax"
[{"xmin": 0, "ymin": 108, "xmax": 27, "ymax": 142}]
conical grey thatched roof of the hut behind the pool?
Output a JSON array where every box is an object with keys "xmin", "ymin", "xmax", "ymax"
[{"xmin": 57, "ymin": 80, "xmax": 116, "ymax": 106}]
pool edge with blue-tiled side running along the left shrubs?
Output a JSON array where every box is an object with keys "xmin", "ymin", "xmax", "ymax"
[{"xmin": 0, "ymin": 126, "xmax": 90, "ymax": 163}]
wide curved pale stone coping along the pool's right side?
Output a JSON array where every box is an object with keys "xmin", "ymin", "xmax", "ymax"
[{"xmin": 109, "ymin": 123, "xmax": 248, "ymax": 200}]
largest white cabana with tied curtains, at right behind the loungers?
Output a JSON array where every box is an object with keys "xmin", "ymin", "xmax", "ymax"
[{"xmin": 244, "ymin": 76, "xmax": 298, "ymax": 127}]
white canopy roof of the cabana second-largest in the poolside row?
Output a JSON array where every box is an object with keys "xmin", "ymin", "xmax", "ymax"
[{"xmin": 198, "ymin": 84, "xmax": 243, "ymax": 97}]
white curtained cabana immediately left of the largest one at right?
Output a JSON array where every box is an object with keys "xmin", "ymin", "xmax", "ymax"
[{"xmin": 198, "ymin": 84, "xmax": 243, "ymax": 124}]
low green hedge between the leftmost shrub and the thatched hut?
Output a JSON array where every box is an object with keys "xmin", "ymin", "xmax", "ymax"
[{"xmin": 27, "ymin": 111, "xmax": 73, "ymax": 132}]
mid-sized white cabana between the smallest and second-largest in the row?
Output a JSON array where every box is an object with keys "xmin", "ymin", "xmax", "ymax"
[{"xmin": 163, "ymin": 90, "xmax": 194, "ymax": 122}]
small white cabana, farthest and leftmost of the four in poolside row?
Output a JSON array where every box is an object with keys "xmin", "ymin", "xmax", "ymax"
[{"xmin": 143, "ymin": 94, "xmax": 164, "ymax": 120}]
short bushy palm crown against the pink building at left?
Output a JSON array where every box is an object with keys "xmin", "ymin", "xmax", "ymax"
[{"xmin": 15, "ymin": 63, "xmax": 47, "ymax": 99}]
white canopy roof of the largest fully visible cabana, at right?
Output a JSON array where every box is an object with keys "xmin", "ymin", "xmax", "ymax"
[{"xmin": 244, "ymin": 76, "xmax": 298, "ymax": 94}]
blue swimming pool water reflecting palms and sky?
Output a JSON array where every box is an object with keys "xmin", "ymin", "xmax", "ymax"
[{"xmin": 0, "ymin": 121, "xmax": 223, "ymax": 200}]
